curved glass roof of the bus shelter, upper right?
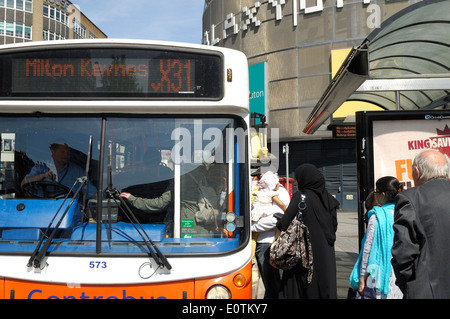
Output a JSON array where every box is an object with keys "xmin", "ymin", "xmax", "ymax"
[{"xmin": 304, "ymin": 0, "xmax": 450, "ymax": 133}]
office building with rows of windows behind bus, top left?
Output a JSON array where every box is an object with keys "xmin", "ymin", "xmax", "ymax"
[{"xmin": 0, "ymin": 0, "xmax": 107, "ymax": 44}]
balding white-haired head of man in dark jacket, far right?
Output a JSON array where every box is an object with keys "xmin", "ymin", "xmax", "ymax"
[{"xmin": 412, "ymin": 150, "xmax": 450, "ymax": 186}]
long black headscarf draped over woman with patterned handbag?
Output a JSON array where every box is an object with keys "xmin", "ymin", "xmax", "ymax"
[{"xmin": 295, "ymin": 164, "xmax": 339, "ymax": 244}]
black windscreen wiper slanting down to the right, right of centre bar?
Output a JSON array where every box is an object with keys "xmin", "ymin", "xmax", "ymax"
[{"xmin": 106, "ymin": 188, "xmax": 172, "ymax": 270}]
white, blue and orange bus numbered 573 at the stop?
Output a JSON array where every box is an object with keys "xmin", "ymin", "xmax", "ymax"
[{"xmin": 0, "ymin": 39, "xmax": 252, "ymax": 299}]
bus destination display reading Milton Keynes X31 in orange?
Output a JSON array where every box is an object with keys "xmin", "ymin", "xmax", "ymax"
[{"xmin": 0, "ymin": 48, "xmax": 223, "ymax": 99}]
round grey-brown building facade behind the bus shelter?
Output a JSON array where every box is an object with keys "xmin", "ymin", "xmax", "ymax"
[{"xmin": 203, "ymin": 0, "xmax": 420, "ymax": 210}]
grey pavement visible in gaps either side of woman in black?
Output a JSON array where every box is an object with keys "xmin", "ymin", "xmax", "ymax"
[{"xmin": 253, "ymin": 212, "xmax": 359, "ymax": 299}]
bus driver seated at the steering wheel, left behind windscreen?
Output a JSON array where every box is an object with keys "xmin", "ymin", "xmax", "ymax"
[{"xmin": 21, "ymin": 141, "xmax": 97, "ymax": 198}]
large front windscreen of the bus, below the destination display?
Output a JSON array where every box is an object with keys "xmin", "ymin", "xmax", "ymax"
[{"xmin": 0, "ymin": 114, "xmax": 249, "ymax": 255}]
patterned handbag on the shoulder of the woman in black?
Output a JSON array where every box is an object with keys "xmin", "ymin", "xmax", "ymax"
[{"xmin": 270, "ymin": 193, "xmax": 313, "ymax": 283}]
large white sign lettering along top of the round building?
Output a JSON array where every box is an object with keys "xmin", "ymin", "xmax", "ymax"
[{"xmin": 203, "ymin": 0, "xmax": 381, "ymax": 45}]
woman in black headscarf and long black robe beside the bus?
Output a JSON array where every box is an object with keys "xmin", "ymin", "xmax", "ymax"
[{"xmin": 277, "ymin": 164, "xmax": 339, "ymax": 299}]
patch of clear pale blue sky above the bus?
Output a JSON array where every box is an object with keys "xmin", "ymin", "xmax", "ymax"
[{"xmin": 71, "ymin": 0, "xmax": 205, "ymax": 44}]
